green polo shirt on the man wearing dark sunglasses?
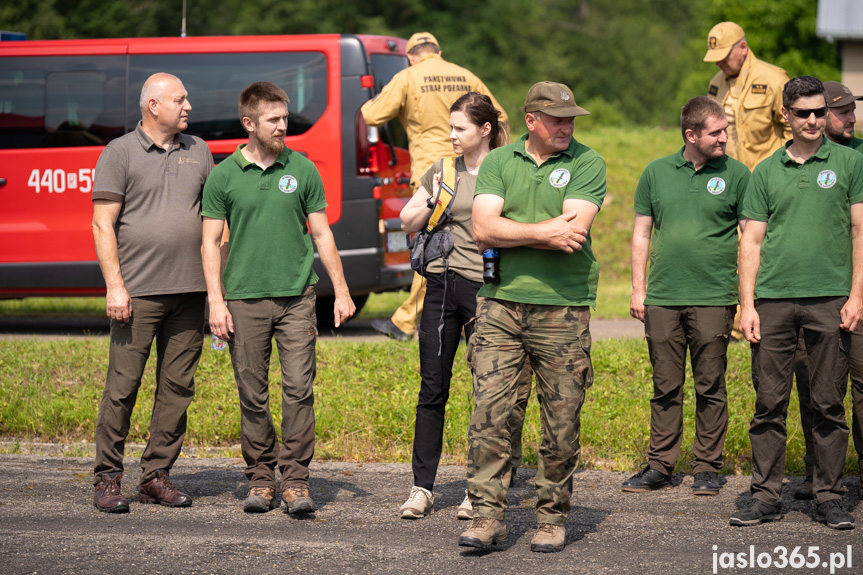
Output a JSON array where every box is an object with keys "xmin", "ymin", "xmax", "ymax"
[{"xmin": 743, "ymin": 138, "xmax": 863, "ymax": 298}]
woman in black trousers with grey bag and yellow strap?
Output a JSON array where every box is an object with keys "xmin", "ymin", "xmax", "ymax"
[{"xmin": 399, "ymin": 92, "xmax": 531, "ymax": 519}]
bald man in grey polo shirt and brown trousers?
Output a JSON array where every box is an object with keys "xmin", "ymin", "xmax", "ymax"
[{"xmin": 93, "ymin": 73, "xmax": 213, "ymax": 513}]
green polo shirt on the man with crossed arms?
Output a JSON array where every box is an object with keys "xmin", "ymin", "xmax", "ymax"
[{"xmin": 475, "ymin": 135, "xmax": 606, "ymax": 306}]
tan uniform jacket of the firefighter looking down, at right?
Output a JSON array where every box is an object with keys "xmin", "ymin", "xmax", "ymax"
[{"xmin": 708, "ymin": 50, "xmax": 791, "ymax": 171}]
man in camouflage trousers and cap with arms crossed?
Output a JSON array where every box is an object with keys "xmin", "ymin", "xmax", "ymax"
[{"xmin": 459, "ymin": 82, "xmax": 606, "ymax": 553}]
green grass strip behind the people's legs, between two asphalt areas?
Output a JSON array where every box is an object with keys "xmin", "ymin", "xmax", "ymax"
[{"xmin": 0, "ymin": 338, "xmax": 857, "ymax": 475}]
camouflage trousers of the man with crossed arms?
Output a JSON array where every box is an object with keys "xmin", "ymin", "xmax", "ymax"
[{"xmin": 467, "ymin": 298, "xmax": 593, "ymax": 525}]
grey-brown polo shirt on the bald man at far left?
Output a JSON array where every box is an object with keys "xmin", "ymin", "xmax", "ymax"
[{"xmin": 93, "ymin": 122, "xmax": 213, "ymax": 297}]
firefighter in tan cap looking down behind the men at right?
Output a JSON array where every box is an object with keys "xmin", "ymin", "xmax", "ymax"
[{"xmin": 704, "ymin": 22, "xmax": 791, "ymax": 170}]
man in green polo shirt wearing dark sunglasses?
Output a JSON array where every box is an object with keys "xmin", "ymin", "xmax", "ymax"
[{"xmin": 731, "ymin": 76, "xmax": 863, "ymax": 529}]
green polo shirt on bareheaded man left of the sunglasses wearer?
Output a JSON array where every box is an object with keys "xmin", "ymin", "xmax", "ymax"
[{"xmin": 635, "ymin": 148, "xmax": 750, "ymax": 306}]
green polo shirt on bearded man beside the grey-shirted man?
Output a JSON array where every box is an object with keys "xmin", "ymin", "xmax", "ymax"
[{"xmin": 201, "ymin": 144, "xmax": 327, "ymax": 299}]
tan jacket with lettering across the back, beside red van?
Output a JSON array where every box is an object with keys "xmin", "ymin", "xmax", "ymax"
[{"xmin": 362, "ymin": 54, "xmax": 507, "ymax": 190}]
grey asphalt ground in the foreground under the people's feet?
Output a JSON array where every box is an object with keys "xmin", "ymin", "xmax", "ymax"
[{"xmin": 0, "ymin": 452, "xmax": 863, "ymax": 575}]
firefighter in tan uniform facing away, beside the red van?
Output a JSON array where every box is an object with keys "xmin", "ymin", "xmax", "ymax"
[{"xmin": 361, "ymin": 32, "xmax": 508, "ymax": 341}]
